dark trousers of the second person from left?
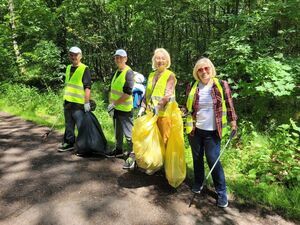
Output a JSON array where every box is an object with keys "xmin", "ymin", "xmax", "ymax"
[{"xmin": 113, "ymin": 114, "xmax": 133, "ymax": 153}]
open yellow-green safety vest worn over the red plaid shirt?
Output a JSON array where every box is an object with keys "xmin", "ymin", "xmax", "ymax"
[{"xmin": 185, "ymin": 78, "xmax": 227, "ymax": 136}]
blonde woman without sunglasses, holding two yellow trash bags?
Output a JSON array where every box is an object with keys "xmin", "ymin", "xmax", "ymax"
[{"xmin": 126, "ymin": 48, "xmax": 177, "ymax": 169}]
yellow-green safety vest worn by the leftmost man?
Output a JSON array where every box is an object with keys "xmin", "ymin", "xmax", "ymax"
[{"xmin": 64, "ymin": 63, "xmax": 86, "ymax": 104}]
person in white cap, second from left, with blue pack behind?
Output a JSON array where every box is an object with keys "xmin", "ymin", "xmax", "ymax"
[{"xmin": 107, "ymin": 49, "xmax": 134, "ymax": 169}]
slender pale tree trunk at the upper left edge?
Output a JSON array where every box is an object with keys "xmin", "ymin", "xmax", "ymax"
[{"xmin": 8, "ymin": 0, "xmax": 25, "ymax": 75}]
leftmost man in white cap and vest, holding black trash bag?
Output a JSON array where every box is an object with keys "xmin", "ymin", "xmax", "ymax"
[{"xmin": 58, "ymin": 46, "xmax": 92, "ymax": 152}]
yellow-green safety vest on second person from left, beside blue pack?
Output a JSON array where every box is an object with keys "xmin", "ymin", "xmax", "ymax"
[{"xmin": 109, "ymin": 66, "xmax": 133, "ymax": 112}]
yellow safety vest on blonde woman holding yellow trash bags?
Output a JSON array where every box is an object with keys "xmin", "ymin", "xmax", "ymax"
[{"xmin": 146, "ymin": 70, "xmax": 177, "ymax": 116}]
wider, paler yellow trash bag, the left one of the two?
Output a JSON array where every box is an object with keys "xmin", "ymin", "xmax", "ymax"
[{"xmin": 132, "ymin": 113, "xmax": 165, "ymax": 171}]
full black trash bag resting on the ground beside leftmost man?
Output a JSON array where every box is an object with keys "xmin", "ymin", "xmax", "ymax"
[{"xmin": 76, "ymin": 112, "xmax": 107, "ymax": 155}]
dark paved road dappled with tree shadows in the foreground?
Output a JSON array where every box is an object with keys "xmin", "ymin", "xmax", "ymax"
[{"xmin": 0, "ymin": 112, "xmax": 295, "ymax": 225}]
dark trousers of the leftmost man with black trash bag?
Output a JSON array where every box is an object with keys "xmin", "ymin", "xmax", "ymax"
[{"xmin": 63, "ymin": 108, "xmax": 84, "ymax": 144}]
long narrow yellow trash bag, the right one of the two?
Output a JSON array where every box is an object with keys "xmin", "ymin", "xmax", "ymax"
[{"xmin": 165, "ymin": 102, "xmax": 186, "ymax": 188}]
